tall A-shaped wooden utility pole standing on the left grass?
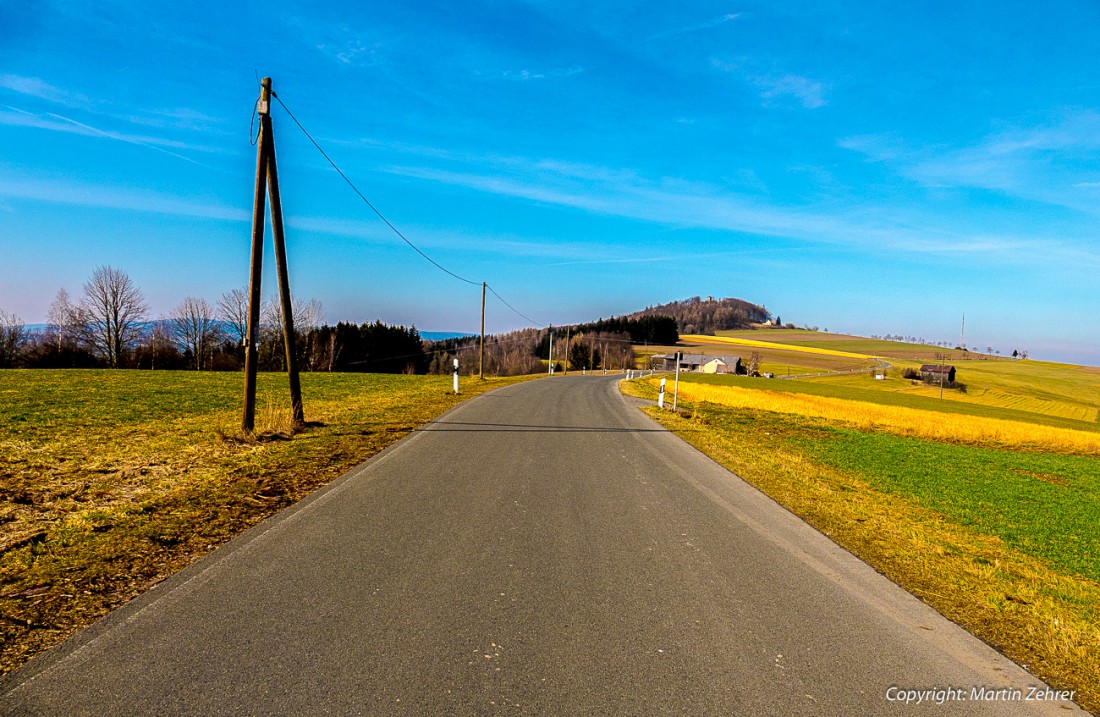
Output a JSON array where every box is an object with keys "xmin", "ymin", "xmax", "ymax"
[{"xmin": 241, "ymin": 77, "xmax": 306, "ymax": 433}]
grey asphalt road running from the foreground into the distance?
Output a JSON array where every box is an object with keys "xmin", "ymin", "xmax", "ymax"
[{"xmin": 0, "ymin": 376, "xmax": 1075, "ymax": 717}]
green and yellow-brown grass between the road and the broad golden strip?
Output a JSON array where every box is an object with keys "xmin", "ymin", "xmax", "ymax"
[{"xmin": 623, "ymin": 380, "xmax": 1100, "ymax": 710}]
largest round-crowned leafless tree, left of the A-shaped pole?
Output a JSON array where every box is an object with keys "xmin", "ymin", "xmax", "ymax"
[{"xmin": 80, "ymin": 266, "xmax": 149, "ymax": 368}]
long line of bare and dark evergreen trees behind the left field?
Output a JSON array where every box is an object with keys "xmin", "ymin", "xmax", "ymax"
[{"xmin": 0, "ymin": 266, "xmax": 712, "ymax": 375}]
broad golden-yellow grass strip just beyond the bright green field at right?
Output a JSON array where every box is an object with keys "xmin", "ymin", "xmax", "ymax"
[{"xmin": 680, "ymin": 382, "xmax": 1100, "ymax": 455}]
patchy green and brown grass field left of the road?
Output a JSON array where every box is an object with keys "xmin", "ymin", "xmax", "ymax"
[{"xmin": 0, "ymin": 369, "xmax": 532, "ymax": 673}]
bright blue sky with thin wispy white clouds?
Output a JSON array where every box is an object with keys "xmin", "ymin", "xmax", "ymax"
[{"xmin": 0, "ymin": 0, "xmax": 1100, "ymax": 365}]
